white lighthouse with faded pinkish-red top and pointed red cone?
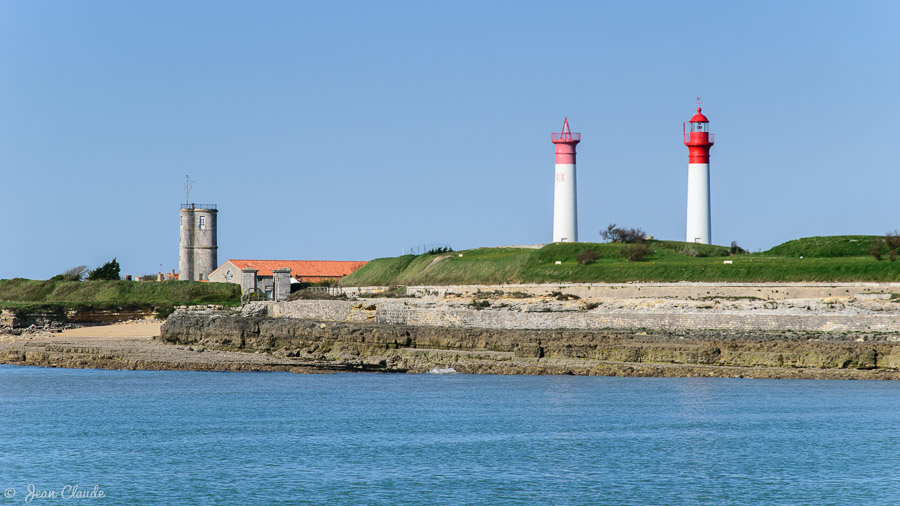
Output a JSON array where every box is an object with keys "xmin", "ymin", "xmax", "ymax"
[{"xmin": 550, "ymin": 117, "xmax": 581, "ymax": 242}]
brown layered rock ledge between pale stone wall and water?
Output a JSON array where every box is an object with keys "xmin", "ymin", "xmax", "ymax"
[{"xmin": 159, "ymin": 308, "xmax": 900, "ymax": 379}]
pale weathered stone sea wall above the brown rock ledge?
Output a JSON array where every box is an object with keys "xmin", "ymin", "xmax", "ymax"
[{"xmin": 269, "ymin": 299, "xmax": 900, "ymax": 339}]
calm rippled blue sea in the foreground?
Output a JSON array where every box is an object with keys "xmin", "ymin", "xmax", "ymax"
[{"xmin": 0, "ymin": 366, "xmax": 900, "ymax": 504}]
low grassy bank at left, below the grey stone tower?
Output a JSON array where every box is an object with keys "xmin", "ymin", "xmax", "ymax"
[{"xmin": 0, "ymin": 278, "xmax": 241, "ymax": 316}]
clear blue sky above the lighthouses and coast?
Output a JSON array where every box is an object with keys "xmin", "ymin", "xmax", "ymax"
[{"xmin": 0, "ymin": 0, "xmax": 900, "ymax": 278}]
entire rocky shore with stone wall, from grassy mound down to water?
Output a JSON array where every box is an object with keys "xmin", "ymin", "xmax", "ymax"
[{"xmin": 0, "ymin": 284, "xmax": 900, "ymax": 379}]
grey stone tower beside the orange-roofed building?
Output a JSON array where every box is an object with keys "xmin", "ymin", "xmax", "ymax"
[{"xmin": 178, "ymin": 204, "xmax": 219, "ymax": 281}]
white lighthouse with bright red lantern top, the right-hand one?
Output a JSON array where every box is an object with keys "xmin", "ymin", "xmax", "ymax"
[{"xmin": 682, "ymin": 107, "xmax": 715, "ymax": 244}]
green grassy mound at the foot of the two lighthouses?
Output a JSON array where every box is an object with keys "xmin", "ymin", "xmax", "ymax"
[{"xmin": 342, "ymin": 236, "xmax": 900, "ymax": 286}]
